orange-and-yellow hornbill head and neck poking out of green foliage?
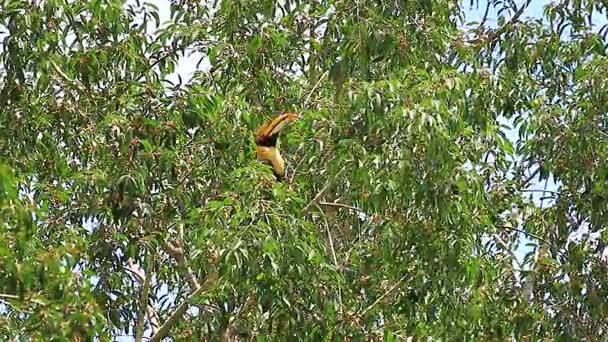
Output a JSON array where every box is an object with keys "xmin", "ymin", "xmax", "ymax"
[{"xmin": 255, "ymin": 113, "xmax": 298, "ymax": 180}]
